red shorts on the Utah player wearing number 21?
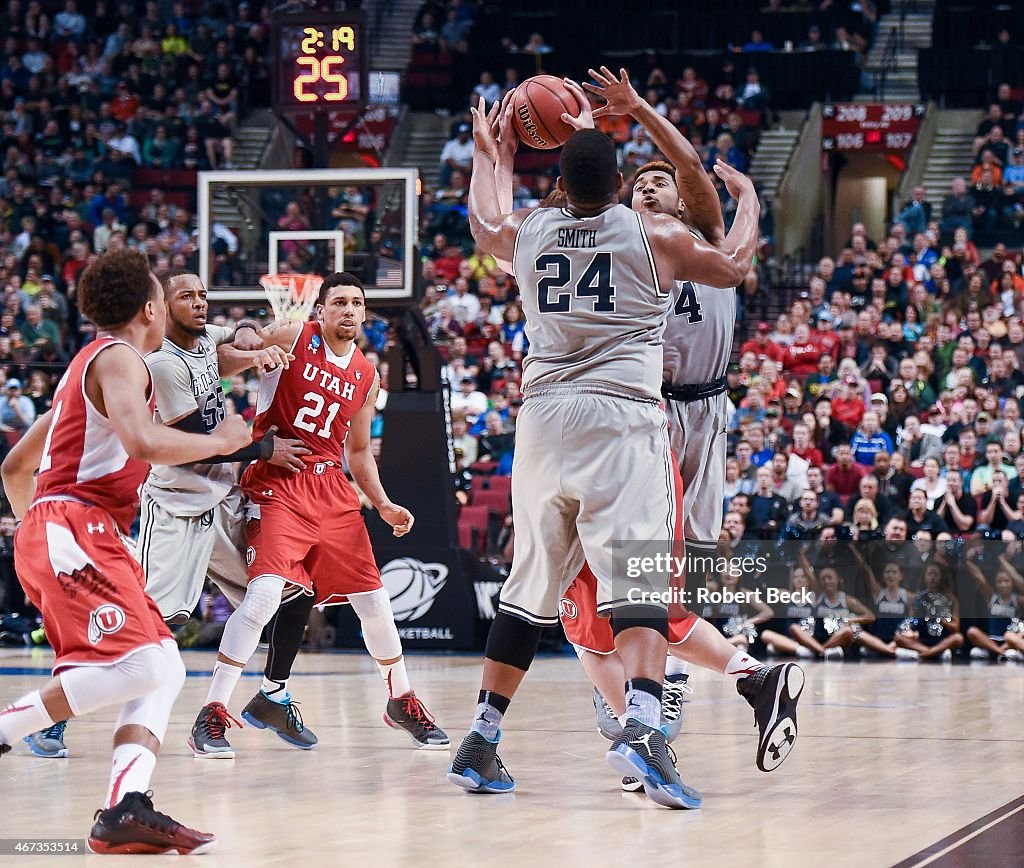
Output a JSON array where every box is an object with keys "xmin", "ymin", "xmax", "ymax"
[{"xmin": 242, "ymin": 464, "xmax": 383, "ymax": 606}]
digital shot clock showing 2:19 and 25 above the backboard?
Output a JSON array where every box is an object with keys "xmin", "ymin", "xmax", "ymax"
[{"xmin": 272, "ymin": 12, "xmax": 368, "ymax": 112}]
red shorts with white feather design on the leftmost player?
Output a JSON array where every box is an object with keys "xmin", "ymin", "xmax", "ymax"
[{"xmin": 14, "ymin": 501, "xmax": 171, "ymax": 672}]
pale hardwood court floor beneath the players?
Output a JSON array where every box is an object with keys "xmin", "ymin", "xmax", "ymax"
[{"xmin": 0, "ymin": 650, "xmax": 1024, "ymax": 868}]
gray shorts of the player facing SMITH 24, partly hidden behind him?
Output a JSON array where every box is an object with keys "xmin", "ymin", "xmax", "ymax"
[{"xmin": 665, "ymin": 392, "xmax": 728, "ymax": 543}]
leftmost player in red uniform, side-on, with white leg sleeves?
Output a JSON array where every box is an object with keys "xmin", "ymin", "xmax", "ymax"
[{"xmin": 0, "ymin": 252, "xmax": 251, "ymax": 855}]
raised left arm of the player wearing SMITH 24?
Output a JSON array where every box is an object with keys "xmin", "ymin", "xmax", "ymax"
[{"xmin": 469, "ymin": 97, "xmax": 527, "ymax": 262}]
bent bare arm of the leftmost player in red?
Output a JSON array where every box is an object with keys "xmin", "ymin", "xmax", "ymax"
[{"xmin": 94, "ymin": 344, "xmax": 252, "ymax": 465}]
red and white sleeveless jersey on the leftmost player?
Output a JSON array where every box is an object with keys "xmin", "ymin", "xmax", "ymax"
[{"xmin": 36, "ymin": 337, "xmax": 156, "ymax": 533}]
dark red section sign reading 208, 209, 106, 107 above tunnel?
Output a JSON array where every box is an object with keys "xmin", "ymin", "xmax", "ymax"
[{"xmin": 821, "ymin": 102, "xmax": 925, "ymax": 154}]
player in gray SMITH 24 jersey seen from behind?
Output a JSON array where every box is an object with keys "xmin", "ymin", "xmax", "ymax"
[{"xmin": 449, "ymin": 87, "xmax": 758, "ymax": 808}]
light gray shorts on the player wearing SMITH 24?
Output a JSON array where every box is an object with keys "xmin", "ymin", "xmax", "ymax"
[{"xmin": 499, "ymin": 393, "xmax": 678, "ymax": 626}]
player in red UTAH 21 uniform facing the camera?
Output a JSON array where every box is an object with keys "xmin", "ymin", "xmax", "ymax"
[{"xmin": 205, "ymin": 271, "xmax": 449, "ymax": 750}]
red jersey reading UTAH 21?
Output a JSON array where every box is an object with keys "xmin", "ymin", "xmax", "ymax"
[{"xmin": 253, "ymin": 322, "xmax": 376, "ymax": 463}]
